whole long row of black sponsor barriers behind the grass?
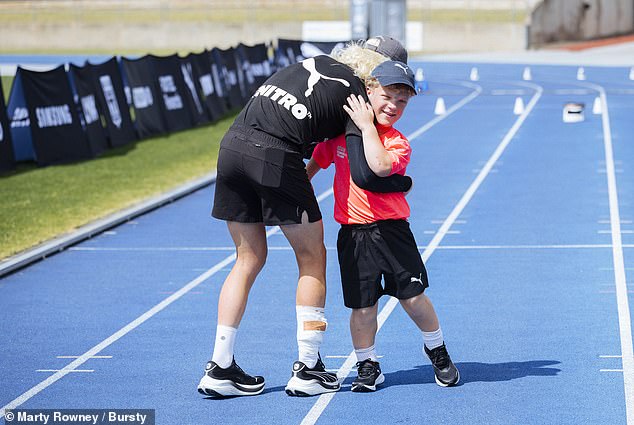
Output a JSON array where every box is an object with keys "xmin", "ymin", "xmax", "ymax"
[{"xmin": 0, "ymin": 39, "xmax": 354, "ymax": 170}]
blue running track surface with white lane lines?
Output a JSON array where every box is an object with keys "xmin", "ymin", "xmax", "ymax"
[{"xmin": 0, "ymin": 62, "xmax": 634, "ymax": 425}]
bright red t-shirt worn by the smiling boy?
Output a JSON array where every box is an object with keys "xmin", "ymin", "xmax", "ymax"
[{"xmin": 313, "ymin": 127, "xmax": 412, "ymax": 224}]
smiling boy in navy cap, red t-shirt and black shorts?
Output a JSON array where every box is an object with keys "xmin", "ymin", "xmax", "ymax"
[{"xmin": 306, "ymin": 61, "xmax": 460, "ymax": 392}]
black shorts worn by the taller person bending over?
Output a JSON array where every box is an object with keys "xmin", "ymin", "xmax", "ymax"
[{"xmin": 211, "ymin": 127, "xmax": 321, "ymax": 226}]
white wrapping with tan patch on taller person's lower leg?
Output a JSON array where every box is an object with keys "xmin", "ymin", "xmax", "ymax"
[{"xmin": 295, "ymin": 305, "xmax": 328, "ymax": 369}]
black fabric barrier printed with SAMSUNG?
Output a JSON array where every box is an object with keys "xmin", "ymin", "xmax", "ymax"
[{"xmin": 18, "ymin": 65, "xmax": 94, "ymax": 165}]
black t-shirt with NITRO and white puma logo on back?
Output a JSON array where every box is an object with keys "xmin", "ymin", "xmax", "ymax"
[{"xmin": 235, "ymin": 56, "xmax": 367, "ymax": 155}]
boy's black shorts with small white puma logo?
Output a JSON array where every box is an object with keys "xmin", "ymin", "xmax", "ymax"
[{"xmin": 337, "ymin": 220, "xmax": 429, "ymax": 308}]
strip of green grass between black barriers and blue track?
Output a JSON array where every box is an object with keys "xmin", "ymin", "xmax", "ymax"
[{"xmin": 0, "ymin": 112, "xmax": 234, "ymax": 258}]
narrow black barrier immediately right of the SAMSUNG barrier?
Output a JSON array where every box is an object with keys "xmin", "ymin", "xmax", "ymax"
[{"xmin": 70, "ymin": 64, "xmax": 108, "ymax": 155}]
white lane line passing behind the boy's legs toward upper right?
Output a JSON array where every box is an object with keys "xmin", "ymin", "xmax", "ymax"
[{"xmin": 301, "ymin": 83, "xmax": 543, "ymax": 425}]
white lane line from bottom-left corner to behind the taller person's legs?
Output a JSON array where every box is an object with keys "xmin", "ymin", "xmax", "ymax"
[{"xmin": 0, "ymin": 188, "xmax": 332, "ymax": 419}]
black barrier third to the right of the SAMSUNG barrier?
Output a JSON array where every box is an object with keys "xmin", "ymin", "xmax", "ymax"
[{"xmin": 121, "ymin": 55, "xmax": 167, "ymax": 139}]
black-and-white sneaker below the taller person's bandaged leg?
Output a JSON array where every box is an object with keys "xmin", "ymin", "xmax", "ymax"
[{"xmin": 286, "ymin": 357, "xmax": 341, "ymax": 397}]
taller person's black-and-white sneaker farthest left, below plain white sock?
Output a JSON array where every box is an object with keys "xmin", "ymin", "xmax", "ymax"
[{"xmin": 198, "ymin": 359, "xmax": 264, "ymax": 397}]
